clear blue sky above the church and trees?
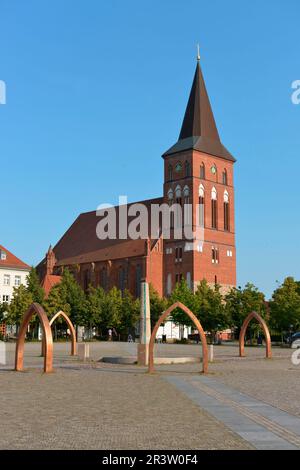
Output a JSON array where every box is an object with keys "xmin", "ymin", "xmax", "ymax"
[{"xmin": 0, "ymin": 0, "xmax": 300, "ymax": 296}]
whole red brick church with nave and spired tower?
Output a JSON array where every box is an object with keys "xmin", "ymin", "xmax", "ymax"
[{"xmin": 38, "ymin": 60, "xmax": 236, "ymax": 296}]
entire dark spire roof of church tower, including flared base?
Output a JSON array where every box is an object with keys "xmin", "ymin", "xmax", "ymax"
[{"xmin": 163, "ymin": 61, "xmax": 235, "ymax": 161}]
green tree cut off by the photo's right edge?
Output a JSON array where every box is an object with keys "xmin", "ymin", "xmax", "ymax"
[{"xmin": 270, "ymin": 277, "xmax": 300, "ymax": 332}]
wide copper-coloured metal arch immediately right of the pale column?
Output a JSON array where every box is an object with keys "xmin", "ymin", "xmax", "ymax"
[{"xmin": 148, "ymin": 302, "xmax": 208, "ymax": 374}]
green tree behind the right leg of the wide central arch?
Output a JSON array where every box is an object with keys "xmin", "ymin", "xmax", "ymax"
[{"xmin": 194, "ymin": 279, "xmax": 229, "ymax": 338}]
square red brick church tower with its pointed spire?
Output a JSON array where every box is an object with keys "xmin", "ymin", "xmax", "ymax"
[{"xmin": 163, "ymin": 56, "xmax": 236, "ymax": 295}]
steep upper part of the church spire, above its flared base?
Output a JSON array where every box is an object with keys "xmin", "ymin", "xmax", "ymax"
[{"xmin": 179, "ymin": 60, "xmax": 220, "ymax": 142}]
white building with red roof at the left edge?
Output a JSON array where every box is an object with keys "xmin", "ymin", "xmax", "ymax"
[{"xmin": 0, "ymin": 245, "xmax": 30, "ymax": 303}]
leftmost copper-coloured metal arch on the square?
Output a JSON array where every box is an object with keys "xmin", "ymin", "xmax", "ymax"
[{"xmin": 15, "ymin": 303, "xmax": 53, "ymax": 373}]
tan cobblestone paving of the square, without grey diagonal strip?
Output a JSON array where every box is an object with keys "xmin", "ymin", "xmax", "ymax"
[{"xmin": 0, "ymin": 343, "xmax": 300, "ymax": 449}]
